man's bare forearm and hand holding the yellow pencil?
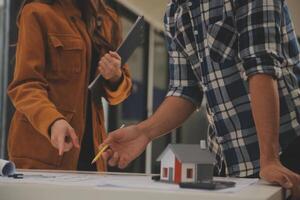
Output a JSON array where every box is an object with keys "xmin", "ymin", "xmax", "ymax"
[{"xmin": 100, "ymin": 97, "xmax": 196, "ymax": 169}]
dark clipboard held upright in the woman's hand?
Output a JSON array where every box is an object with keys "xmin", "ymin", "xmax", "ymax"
[{"xmin": 88, "ymin": 16, "xmax": 145, "ymax": 100}]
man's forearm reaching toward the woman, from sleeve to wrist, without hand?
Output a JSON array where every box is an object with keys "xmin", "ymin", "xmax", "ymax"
[{"xmin": 138, "ymin": 97, "xmax": 196, "ymax": 140}]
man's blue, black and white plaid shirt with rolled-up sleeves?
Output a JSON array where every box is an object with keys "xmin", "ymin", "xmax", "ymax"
[{"xmin": 165, "ymin": 0, "xmax": 300, "ymax": 177}]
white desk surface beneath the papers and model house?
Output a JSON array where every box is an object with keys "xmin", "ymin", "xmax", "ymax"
[{"xmin": 0, "ymin": 170, "xmax": 284, "ymax": 200}]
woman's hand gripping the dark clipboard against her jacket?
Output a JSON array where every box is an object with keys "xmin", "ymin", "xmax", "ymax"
[{"xmin": 98, "ymin": 51, "xmax": 122, "ymax": 84}]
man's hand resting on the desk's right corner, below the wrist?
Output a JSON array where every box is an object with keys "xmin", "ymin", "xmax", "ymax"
[{"xmin": 260, "ymin": 161, "xmax": 300, "ymax": 200}]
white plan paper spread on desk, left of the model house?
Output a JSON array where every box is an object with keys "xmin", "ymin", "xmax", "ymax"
[{"xmin": 0, "ymin": 172, "xmax": 179, "ymax": 190}]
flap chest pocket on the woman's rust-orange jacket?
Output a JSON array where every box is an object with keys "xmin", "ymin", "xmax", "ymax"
[{"xmin": 49, "ymin": 34, "xmax": 84, "ymax": 75}]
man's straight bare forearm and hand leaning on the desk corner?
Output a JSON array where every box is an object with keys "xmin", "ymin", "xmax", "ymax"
[{"xmin": 249, "ymin": 74, "xmax": 300, "ymax": 199}]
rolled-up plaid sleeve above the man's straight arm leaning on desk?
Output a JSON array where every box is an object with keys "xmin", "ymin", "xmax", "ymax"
[{"xmin": 235, "ymin": 0, "xmax": 284, "ymax": 79}]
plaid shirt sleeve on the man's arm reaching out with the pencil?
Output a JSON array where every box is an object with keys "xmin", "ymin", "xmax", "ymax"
[{"xmin": 165, "ymin": 13, "xmax": 203, "ymax": 107}]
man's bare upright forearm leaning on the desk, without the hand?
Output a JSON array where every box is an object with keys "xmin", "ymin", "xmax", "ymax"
[{"xmin": 249, "ymin": 75, "xmax": 279, "ymax": 166}]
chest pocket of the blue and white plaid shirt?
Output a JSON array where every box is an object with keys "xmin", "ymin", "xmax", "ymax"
[{"xmin": 207, "ymin": 16, "xmax": 238, "ymax": 63}]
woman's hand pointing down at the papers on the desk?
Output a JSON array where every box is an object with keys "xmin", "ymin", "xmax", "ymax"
[{"xmin": 51, "ymin": 119, "xmax": 80, "ymax": 156}]
